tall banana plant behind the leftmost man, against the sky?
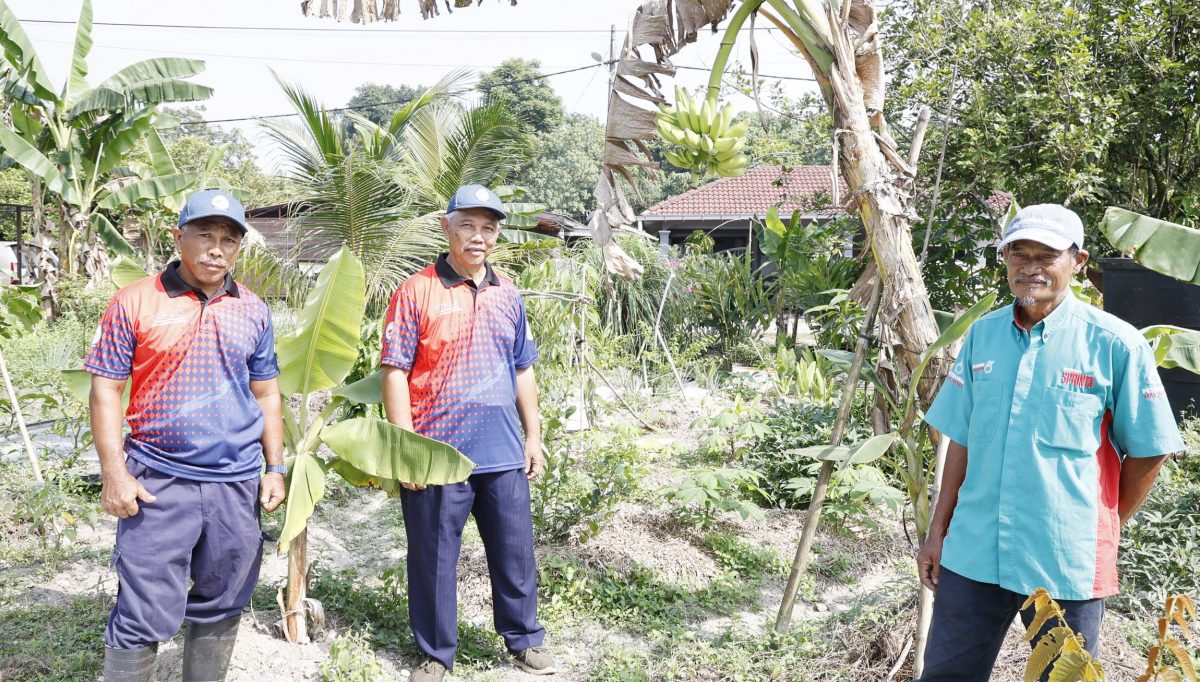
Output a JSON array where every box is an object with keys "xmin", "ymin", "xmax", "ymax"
[{"xmin": 0, "ymin": 0, "xmax": 212, "ymax": 279}]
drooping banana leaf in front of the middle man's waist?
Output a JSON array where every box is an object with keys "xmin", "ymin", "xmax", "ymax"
[{"xmin": 320, "ymin": 418, "xmax": 475, "ymax": 485}]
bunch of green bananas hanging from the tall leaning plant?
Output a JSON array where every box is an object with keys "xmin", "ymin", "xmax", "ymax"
[{"xmin": 654, "ymin": 86, "xmax": 750, "ymax": 178}]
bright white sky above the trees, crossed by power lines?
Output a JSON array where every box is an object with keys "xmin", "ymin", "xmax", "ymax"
[{"xmin": 6, "ymin": 0, "xmax": 812, "ymax": 171}]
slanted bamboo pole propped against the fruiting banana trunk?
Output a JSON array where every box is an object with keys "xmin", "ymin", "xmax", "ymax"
[{"xmin": 775, "ymin": 277, "xmax": 883, "ymax": 634}]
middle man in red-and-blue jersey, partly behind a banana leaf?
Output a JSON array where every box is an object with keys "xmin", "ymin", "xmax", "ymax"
[{"xmin": 380, "ymin": 185, "xmax": 554, "ymax": 682}]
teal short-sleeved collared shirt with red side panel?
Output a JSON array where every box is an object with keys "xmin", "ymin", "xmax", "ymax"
[{"xmin": 925, "ymin": 295, "xmax": 1183, "ymax": 600}]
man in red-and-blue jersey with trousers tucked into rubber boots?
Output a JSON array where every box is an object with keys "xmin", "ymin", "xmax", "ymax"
[{"xmin": 84, "ymin": 190, "xmax": 286, "ymax": 682}]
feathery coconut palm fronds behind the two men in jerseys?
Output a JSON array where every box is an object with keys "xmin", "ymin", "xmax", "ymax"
[{"xmin": 264, "ymin": 72, "xmax": 541, "ymax": 310}]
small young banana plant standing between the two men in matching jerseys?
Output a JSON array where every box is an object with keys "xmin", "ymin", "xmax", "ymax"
[{"xmin": 276, "ymin": 247, "xmax": 474, "ymax": 642}]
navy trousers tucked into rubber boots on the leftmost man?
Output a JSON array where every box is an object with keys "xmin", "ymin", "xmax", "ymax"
[{"xmin": 104, "ymin": 457, "xmax": 263, "ymax": 648}]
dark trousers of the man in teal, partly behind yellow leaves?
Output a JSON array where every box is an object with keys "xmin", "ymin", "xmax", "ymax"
[{"xmin": 920, "ymin": 566, "xmax": 1104, "ymax": 682}]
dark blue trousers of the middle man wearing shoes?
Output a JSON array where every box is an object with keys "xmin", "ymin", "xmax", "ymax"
[{"xmin": 400, "ymin": 468, "xmax": 546, "ymax": 668}]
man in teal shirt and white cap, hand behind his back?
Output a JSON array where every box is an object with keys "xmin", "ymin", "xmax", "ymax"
[{"xmin": 917, "ymin": 204, "xmax": 1183, "ymax": 682}]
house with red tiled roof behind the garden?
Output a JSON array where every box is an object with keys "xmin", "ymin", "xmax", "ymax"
[{"xmin": 637, "ymin": 166, "xmax": 846, "ymax": 258}]
